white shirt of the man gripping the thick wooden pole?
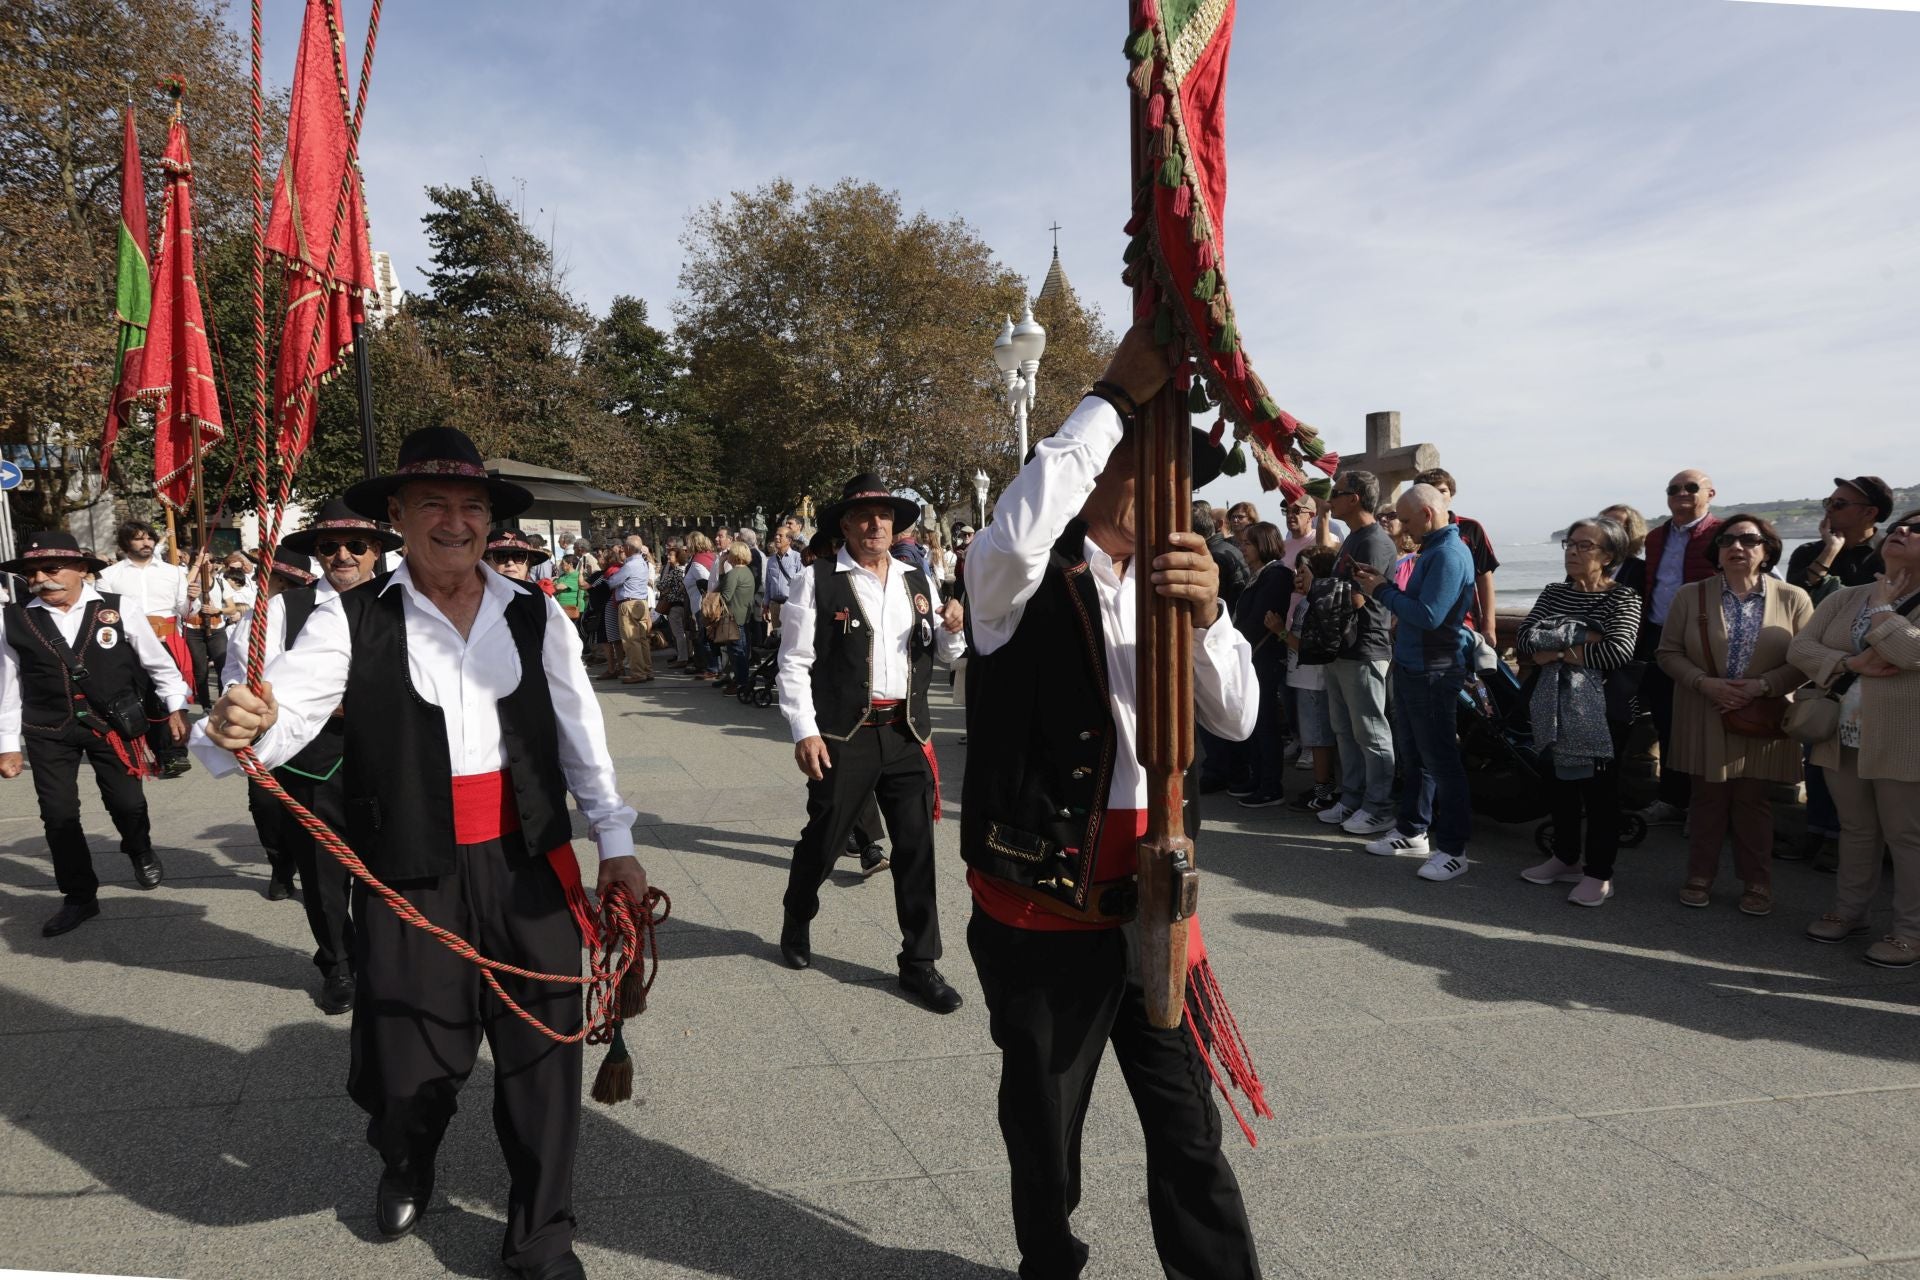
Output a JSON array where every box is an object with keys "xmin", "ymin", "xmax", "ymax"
[{"xmin": 966, "ymin": 395, "xmax": 1260, "ymax": 810}]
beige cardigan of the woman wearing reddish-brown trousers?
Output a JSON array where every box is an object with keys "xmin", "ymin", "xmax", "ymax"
[{"xmin": 1659, "ymin": 574, "xmax": 1812, "ymax": 783}]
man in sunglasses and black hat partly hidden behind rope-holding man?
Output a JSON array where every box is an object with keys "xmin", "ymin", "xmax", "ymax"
[{"xmin": 223, "ymin": 499, "xmax": 401, "ymax": 1013}]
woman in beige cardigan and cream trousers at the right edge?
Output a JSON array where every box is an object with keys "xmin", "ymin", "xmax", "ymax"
[{"xmin": 1789, "ymin": 510, "xmax": 1920, "ymax": 969}]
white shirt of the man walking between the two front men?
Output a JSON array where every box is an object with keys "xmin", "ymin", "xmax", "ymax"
[{"xmin": 780, "ymin": 549, "xmax": 966, "ymax": 743}]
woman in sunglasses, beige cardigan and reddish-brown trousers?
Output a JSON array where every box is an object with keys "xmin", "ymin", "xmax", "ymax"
[{"xmin": 1659, "ymin": 512, "xmax": 1812, "ymax": 915}]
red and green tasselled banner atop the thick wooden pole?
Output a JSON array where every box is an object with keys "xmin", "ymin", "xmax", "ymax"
[{"xmin": 1123, "ymin": 0, "xmax": 1340, "ymax": 499}]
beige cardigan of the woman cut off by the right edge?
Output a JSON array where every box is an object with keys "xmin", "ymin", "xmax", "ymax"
[{"xmin": 1788, "ymin": 583, "xmax": 1920, "ymax": 783}]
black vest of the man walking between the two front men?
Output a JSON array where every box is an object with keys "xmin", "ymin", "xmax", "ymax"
[{"xmin": 812, "ymin": 557, "xmax": 939, "ymax": 743}]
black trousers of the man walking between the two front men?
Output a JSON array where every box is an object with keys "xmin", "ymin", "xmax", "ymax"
[{"xmin": 783, "ymin": 723, "xmax": 941, "ymax": 969}]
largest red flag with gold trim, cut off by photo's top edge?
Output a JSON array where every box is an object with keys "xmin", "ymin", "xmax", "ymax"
[{"xmin": 267, "ymin": 0, "xmax": 372, "ymax": 461}]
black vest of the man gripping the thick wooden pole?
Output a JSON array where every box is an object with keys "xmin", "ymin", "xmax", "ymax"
[{"xmin": 960, "ymin": 520, "xmax": 1198, "ymax": 912}]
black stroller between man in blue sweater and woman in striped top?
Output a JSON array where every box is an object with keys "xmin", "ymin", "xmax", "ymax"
[{"xmin": 1459, "ymin": 662, "xmax": 1647, "ymax": 854}]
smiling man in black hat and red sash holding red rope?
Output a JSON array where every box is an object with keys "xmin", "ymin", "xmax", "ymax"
[{"xmin": 196, "ymin": 428, "xmax": 647, "ymax": 1280}]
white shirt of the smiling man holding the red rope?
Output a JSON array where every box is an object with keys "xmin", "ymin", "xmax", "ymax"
[{"xmin": 192, "ymin": 562, "xmax": 637, "ymax": 858}]
